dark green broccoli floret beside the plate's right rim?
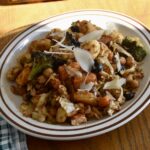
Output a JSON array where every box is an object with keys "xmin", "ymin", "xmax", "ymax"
[{"xmin": 122, "ymin": 37, "xmax": 146, "ymax": 62}]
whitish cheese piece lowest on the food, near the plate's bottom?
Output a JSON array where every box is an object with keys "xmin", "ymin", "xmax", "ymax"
[{"xmin": 59, "ymin": 97, "xmax": 75, "ymax": 115}]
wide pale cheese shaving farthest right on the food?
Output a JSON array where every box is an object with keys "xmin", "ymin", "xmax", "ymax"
[{"xmin": 103, "ymin": 76, "xmax": 126, "ymax": 89}]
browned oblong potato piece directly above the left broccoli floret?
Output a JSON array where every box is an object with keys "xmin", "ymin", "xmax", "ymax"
[{"xmin": 29, "ymin": 39, "xmax": 52, "ymax": 52}]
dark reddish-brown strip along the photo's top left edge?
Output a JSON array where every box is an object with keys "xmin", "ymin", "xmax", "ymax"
[{"xmin": 0, "ymin": 0, "xmax": 63, "ymax": 6}]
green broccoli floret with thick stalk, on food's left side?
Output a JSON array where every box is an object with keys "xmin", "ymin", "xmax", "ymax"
[{"xmin": 28, "ymin": 52, "xmax": 53, "ymax": 80}]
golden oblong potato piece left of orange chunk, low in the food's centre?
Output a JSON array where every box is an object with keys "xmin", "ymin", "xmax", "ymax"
[{"xmin": 74, "ymin": 91, "xmax": 97, "ymax": 105}]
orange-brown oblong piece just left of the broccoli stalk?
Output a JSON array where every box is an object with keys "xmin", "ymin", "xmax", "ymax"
[{"xmin": 16, "ymin": 67, "xmax": 31, "ymax": 86}]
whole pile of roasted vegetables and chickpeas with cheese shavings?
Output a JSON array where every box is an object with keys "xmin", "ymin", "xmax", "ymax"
[{"xmin": 7, "ymin": 20, "xmax": 146, "ymax": 125}]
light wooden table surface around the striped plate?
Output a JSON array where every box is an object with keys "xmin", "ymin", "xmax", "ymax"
[{"xmin": 0, "ymin": 0, "xmax": 150, "ymax": 150}]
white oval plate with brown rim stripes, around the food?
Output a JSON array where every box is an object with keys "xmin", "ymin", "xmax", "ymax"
[{"xmin": 0, "ymin": 10, "xmax": 150, "ymax": 140}]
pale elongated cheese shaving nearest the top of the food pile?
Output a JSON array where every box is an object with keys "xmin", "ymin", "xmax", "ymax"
[{"xmin": 78, "ymin": 30, "xmax": 104, "ymax": 43}]
